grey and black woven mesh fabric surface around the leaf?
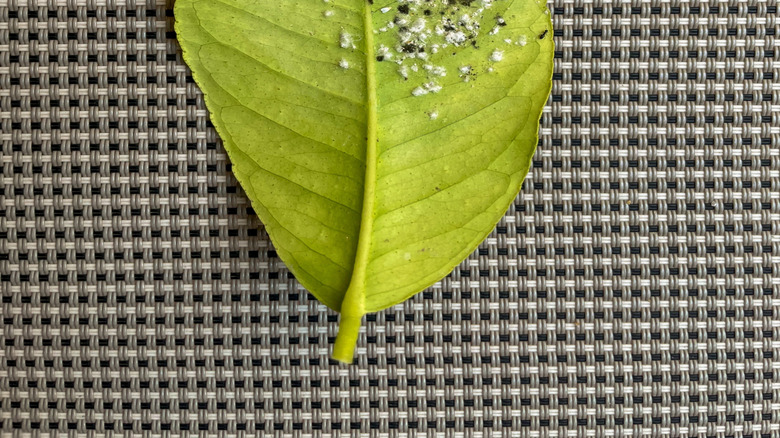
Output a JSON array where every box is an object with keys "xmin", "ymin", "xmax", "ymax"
[{"xmin": 0, "ymin": 0, "xmax": 780, "ymax": 437}]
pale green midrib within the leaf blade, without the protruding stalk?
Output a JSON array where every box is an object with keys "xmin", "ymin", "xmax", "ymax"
[{"xmin": 341, "ymin": 0, "xmax": 377, "ymax": 319}]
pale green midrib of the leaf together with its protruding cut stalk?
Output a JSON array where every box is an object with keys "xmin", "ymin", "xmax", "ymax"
[{"xmin": 332, "ymin": 0, "xmax": 377, "ymax": 363}]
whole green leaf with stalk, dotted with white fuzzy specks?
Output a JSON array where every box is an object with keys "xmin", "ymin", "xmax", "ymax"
[{"xmin": 175, "ymin": 0, "xmax": 553, "ymax": 362}]
